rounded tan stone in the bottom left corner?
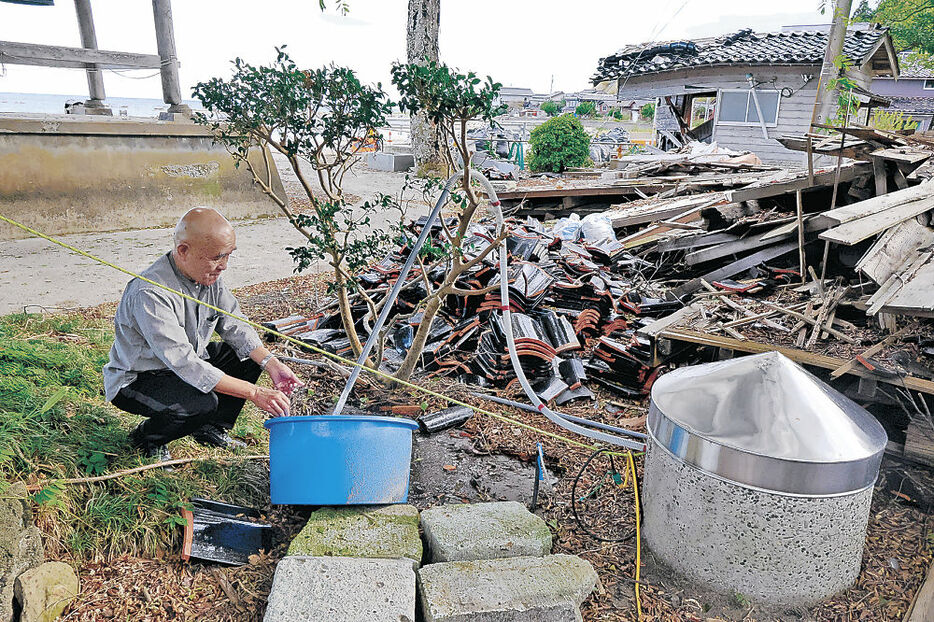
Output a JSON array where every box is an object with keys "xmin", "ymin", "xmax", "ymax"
[{"xmin": 13, "ymin": 562, "xmax": 78, "ymax": 622}]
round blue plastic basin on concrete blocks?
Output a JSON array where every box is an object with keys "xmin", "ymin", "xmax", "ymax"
[{"xmin": 264, "ymin": 415, "xmax": 418, "ymax": 505}]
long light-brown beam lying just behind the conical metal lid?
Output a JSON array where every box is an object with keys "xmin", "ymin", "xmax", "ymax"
[{"xmin": 658, "ymin": 328, "xmax": 934, "ymax": 395}]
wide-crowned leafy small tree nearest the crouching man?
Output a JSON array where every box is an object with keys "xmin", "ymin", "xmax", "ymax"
[{"xmin": 194, "ymin": 52, "xmax": 401, "ymax": 364}]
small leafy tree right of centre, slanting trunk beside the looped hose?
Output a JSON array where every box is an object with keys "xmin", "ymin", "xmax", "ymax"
[{"xmin": 392, "ymin": 62, "xmax": 506, "ymax": 380}]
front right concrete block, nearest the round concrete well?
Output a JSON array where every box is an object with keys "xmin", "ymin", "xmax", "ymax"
[{"xmin": 418, "ymin": 555, "xmax": 597, "ymax": 622}]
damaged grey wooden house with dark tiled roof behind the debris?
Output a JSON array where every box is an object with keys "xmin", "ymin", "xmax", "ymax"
[{"xmin": 592, "ymin": 24, "xmax": 898, "ymax": 162}]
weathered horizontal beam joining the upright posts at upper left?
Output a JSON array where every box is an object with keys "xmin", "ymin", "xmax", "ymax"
[{"xmin": 0, "ymin": 41, "xmax": 162, "ymax": 69}]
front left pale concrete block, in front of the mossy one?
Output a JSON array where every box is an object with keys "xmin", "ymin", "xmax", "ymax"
[{"xmin": 263, "ymin": 556, "xmax": 415, "ymax": 622}]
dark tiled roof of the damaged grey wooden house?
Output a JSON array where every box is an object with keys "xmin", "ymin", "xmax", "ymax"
[{"xmin": 593, "ymin": 28, "xmax": 888, "ymax": 84}]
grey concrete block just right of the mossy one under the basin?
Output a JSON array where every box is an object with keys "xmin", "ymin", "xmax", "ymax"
[{"xmin": 422, "ymin": 501, "xmax": 551, "ymax": 563}]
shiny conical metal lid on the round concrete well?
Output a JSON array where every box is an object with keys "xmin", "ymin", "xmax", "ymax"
[{"xmin": 647, "ymin": 352, "xmax": 888, "ymax": 496}]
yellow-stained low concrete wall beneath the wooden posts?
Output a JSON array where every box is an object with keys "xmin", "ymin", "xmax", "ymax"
[{"xmin": 0, "ymin": 115, "xmax": 285, "ymax": 239}]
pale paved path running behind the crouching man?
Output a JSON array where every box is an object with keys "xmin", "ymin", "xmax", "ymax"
[{"xmin": 0, "ymin": 167, "xmax": 425, "ymax": 315}]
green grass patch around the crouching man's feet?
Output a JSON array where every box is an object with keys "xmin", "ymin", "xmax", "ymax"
[{"xmin": 0, "ymin": 314, "xmax": 268, "ymax": 560}]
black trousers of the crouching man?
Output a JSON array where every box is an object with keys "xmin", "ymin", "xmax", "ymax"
[{"xmin": 111, "ymin": 341, "xmax": 262, "ymax": 448}]
